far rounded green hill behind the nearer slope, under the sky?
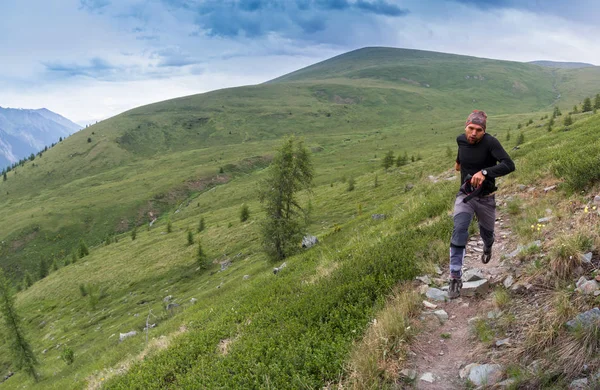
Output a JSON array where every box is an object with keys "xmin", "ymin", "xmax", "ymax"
[{"xmin": 0, "ymin": 48, "xmax": 600, "ymax": 279}]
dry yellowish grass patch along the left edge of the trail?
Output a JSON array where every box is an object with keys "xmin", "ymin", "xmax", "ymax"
[{"xmin": 342, "ymin": 284, "xmax": 421, "ymax": 389}]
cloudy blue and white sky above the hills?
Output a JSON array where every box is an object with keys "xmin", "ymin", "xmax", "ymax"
[{"xmin": 0, "ymin": 0, "xmax": 600, "ymax": 124}]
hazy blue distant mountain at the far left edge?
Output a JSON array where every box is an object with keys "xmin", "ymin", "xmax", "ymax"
[{"xmin": 0, "ymin": 107, "xmax": 81, "ymax": 168}]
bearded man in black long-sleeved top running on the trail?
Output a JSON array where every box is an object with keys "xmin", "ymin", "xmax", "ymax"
[{"xmin": 448, "ymin": 110, "xmax": 515, "ymax": 298}]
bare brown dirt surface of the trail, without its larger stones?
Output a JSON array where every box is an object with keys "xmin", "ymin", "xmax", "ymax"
[{"xmin": 407, "ymin": 199, "xmax": 511, "ymax": 390}]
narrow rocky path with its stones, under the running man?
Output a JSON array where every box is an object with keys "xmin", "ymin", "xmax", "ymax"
[{"xmin": 403, "ymin": 200, "xmax": 512, "ymax": 390}]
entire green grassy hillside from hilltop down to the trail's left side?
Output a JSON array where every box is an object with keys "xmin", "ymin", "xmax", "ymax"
[{"xmin": 0, "ymin": 48, "xmax": 600, "ymax": 388}]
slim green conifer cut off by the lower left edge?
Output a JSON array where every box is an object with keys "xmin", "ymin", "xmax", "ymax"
[{"xmin": 0, "ymin": 269, "xmax": 39, "ymax": 382}]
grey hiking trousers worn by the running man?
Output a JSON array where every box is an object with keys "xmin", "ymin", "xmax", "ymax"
[{"xmin": 450, "ymin": 192, "xmax": 496, "ymax": 278}]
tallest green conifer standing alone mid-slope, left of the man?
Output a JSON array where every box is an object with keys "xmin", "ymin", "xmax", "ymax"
[{"xmin": 259, "ymin": 137, "xmax": 314, "ymax": 260}]
